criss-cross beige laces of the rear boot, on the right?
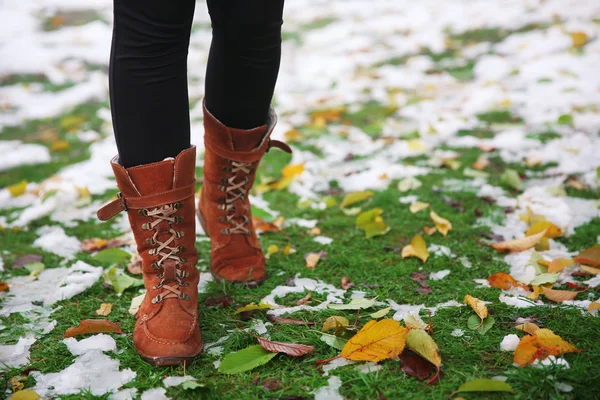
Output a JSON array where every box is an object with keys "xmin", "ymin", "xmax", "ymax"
[{"xmin": 219, "ymin": 160, "xmax": 255, "ymax": 235}]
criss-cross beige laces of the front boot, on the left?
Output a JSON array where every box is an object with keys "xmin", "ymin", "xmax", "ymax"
[{"xmin": 140, "ymin": 203, "xmax": 190, "ymax": 304}]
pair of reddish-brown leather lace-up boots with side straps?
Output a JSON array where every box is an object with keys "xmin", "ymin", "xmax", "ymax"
[{"xmin": 98, "ymin": 104, "xmax": 291, "ymax": 365}]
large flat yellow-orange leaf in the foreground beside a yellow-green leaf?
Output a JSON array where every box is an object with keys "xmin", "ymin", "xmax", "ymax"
[{"xmin": 340, "ymin": 318, "xmax": 407, "ymax": 362}]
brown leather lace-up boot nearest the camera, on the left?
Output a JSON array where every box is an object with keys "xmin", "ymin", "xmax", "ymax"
[{"xmin": 98, "ymin": 146, "xmax": 202, "ymax": 366}]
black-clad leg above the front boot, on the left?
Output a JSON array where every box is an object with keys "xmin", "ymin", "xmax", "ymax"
[{"xmin": 109, "ymin": 0, "xmax": 195, "ymax": 168}]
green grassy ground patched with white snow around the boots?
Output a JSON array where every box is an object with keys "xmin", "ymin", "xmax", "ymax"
[{"xmin": 0, "ymin": 0, "xmax": 600, "ymax": 399}]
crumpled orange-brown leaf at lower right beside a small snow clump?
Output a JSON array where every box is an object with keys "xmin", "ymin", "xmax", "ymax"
[{"xmin": 514, "ymin": 329, "xmax": 578, "ymax": 367}]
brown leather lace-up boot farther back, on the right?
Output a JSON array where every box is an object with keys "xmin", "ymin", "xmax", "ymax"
[{"xmin": 198, "ymin": 103, "xmax": 292, "ymax": 286}]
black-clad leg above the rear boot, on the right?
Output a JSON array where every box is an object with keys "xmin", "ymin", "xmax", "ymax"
[{"xmin": 206, "ymin": 0, "xmax": 283, "ymax": 129}]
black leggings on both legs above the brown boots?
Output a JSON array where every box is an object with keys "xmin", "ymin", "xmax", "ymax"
[{"xmin": 109, "ymin": 0, "xmax": 283, "ymax": 168}]
